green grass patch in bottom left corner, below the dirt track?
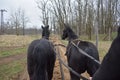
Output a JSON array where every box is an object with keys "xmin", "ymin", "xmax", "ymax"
[{"xmin": 0, "ymin": 59, "xmax": 26, "ymax": 80}]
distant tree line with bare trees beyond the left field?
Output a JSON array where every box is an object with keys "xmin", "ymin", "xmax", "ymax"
[{"xmin": 0, "ymin": 8, "xmax": 41, "ymax": 35}]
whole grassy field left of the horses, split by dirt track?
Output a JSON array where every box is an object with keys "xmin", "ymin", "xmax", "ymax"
[{"xmin": 0, "ymin": 35, "xmax": 40, "ymax": 80}]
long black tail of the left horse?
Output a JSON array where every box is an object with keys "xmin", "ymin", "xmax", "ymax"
[{"xmin": 33, "ymin": 46, "xmax": 47, "ymax": 80}]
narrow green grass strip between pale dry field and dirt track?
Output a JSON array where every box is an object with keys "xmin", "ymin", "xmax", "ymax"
[{"xmin": 0, "ymin": 47, "xmax": 26, "ymax": 58}]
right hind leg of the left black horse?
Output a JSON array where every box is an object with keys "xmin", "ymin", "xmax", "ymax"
[{"xmin": 47, "ymin": 53, "xmax": 56, "ymax": 80}]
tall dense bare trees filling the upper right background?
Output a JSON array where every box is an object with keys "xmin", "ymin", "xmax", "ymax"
[{"xmin": 36, "ymin": 0, "xmax": 120, "ymax": 40}]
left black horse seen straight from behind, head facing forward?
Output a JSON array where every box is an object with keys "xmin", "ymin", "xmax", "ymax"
[{"xmin": 27, "ymin": 26, "xmax": 56, "ymax": 80}]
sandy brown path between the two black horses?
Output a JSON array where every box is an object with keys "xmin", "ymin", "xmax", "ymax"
[{"xmin": 52, "ymin": 38, "xmax": 70, "ymax": 80}]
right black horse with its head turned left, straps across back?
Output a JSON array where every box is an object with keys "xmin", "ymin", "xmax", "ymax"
[{"xmin": 62, "ymin": 24, "xmax": 99, "ymax": 80}]
